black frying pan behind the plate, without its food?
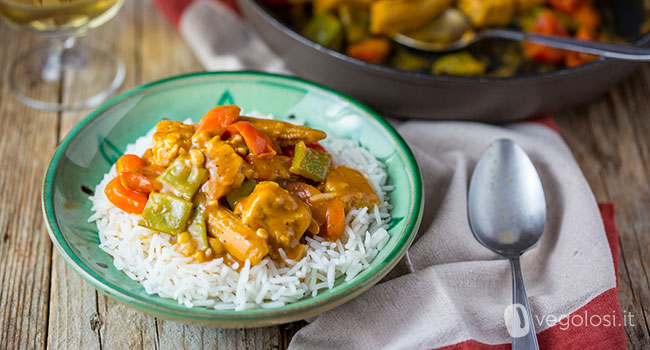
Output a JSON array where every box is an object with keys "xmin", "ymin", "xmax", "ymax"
[{"xmin": 238, "ymin": 0, "xmax": 650, "ymax": 122}]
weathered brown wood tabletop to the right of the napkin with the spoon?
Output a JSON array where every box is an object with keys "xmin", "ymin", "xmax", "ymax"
[{"xmin": 558, "ymin": 65, "xmax": 650, "ymax": 349}]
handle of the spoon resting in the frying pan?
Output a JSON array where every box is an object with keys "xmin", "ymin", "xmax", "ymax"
[{"xmin": 478, "ymin": 29, "xmax": 650, "ymax": 61}]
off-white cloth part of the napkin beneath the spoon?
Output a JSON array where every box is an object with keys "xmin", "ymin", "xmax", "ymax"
[{"xmin": 289, "ymin": 122, "xmax": 616, "ymax": 350}]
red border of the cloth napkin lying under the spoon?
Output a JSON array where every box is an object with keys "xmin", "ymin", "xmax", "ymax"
[{"xmin": 438, "ymin": 204, "xmax": 625, "ymax": 350}]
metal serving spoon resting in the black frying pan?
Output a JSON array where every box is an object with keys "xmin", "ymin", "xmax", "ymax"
[{"xmin": 392, "ymin": 9, "xmax": 650, "ymax": 61}]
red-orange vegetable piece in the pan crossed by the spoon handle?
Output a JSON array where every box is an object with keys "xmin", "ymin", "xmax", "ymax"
[{"xmin": 524, "ymin": 10, "xmax": 567, "ymax": 63}]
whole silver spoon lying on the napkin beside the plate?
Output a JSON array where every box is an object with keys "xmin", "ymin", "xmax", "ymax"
[{"xmin": 467, "ymin": 139, "xmax": 546, "ymax": 350}]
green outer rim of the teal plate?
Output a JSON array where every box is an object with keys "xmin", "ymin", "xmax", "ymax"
[{"xmin": 41, "ymin": 71, "xmax": 424, "ymax": 323}]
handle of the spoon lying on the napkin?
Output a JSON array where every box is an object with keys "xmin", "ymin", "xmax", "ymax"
[{"xmin": 510, "ymin": 256, "xmax": 539, "ymax": 350}]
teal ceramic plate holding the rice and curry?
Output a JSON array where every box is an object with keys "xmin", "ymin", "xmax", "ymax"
[{"xmin": 42, "ymin": 72, "xmax": 423, "ymax": 327}]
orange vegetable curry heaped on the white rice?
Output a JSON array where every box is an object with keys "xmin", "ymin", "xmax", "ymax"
[{"xmin": 105, "ymin": 105, "xmax": 379, "ymax": 266}]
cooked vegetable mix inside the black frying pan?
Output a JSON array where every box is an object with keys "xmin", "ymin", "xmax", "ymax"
[{"xmin": 262, "ymin": 0, "xmax": 619, "ymax": 77}]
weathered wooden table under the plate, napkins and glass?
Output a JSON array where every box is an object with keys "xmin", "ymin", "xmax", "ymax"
[{"xmin": 0, "ymin": 0, "xmax": 650, "ymax": 350}]
